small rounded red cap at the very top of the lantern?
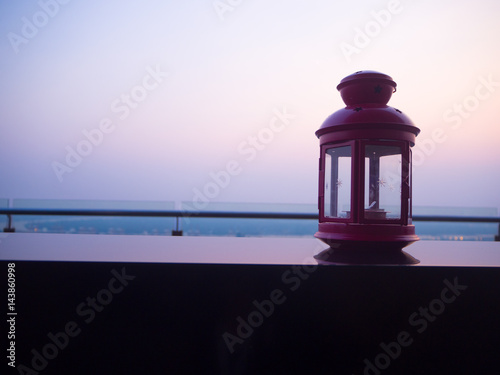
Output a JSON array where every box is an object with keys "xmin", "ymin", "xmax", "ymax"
[{"xmin": 337, "ymin": 70, "xmax": 396, "ymax": 107}]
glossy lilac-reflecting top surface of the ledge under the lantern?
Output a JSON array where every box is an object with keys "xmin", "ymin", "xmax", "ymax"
[{"xmin": 0, "ymin": 233, "xmax": 500, "ymax": 267}]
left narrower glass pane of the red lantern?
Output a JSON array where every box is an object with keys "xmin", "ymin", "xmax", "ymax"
[{"xmin": 324, "ymin": 146, "xmax": 352, "ymax": 219}]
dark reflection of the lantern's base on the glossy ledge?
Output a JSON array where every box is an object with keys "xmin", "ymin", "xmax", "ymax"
[{"xmin": 314, "ymin": 247, "xmax": 420, "ymax": 266}]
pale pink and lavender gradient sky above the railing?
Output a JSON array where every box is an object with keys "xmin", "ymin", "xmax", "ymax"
[{"xmin": 0, "ymin": 0, "xmax": 500, "ymax": 212}]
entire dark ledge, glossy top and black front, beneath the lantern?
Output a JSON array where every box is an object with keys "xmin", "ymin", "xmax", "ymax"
[{"xmin": 0, "ymin": 233, "xmax": 500, "ymax": 375}]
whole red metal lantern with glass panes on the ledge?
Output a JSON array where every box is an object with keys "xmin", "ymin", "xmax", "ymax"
[{"xmin": 315, "ymin": 70, "xmax": 420, "ymax": 250}]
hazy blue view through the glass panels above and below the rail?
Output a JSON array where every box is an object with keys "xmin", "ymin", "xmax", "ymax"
[{"xmin": 0, "ymin": 199, "xmax": 499, "ymax": 241}]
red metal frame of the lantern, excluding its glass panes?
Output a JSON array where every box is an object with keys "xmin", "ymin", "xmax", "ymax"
[{"xmin": 315, "ymin": 71, "xmax": 420, "ymax": 250}]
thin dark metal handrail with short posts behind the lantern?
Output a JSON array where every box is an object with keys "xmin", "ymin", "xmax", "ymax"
[{"xmin": 0, "ymin": 208, "xmax": 500, "ymax": 241}]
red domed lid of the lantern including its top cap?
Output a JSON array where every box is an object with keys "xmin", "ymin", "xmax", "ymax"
[{"xmin": 316, "ymin": 70, "xmax": 420, "ymax": 137}]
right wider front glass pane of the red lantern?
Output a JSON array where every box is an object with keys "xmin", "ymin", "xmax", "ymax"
[{"xmin": 364, "ymin": 145, "xmax": 402, "ymax": 220}]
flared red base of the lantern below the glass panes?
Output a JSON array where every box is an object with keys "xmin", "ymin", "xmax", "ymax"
[{"xmin": 314, "ymin": 222, "xmax": 419, "ymax": 251}]
